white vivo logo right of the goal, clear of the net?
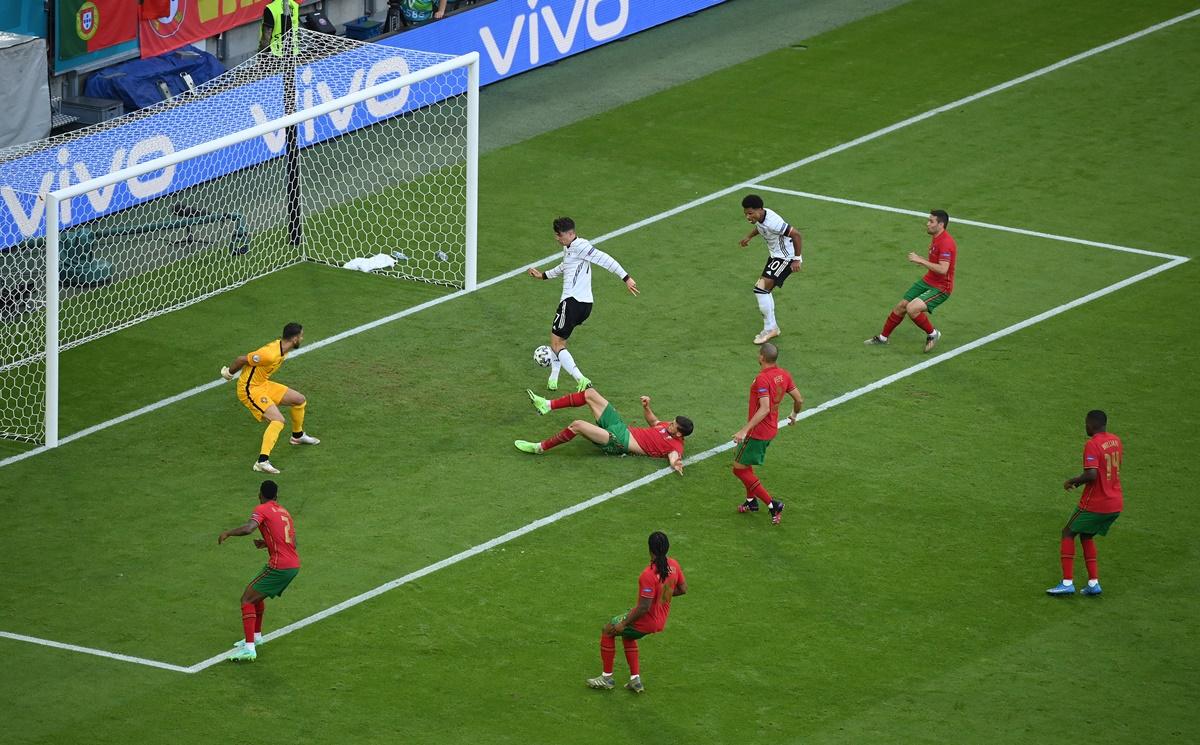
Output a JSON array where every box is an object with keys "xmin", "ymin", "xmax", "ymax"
[{"xmin": 479, "ymin": 0, "xmax": 629, "ymax": 76}]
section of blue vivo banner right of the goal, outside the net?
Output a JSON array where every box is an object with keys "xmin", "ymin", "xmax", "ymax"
[{"xmin": 379, "ymin": 0, "xmax": 726, "ymax": 85}]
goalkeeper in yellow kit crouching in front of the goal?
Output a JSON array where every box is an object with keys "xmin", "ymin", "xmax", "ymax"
[{"xmin": 221, "ymin": 324, "xmax": 320, "ymax": 474}]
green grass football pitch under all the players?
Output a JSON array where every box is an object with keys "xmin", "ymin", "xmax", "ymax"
[{"xmin": 0, "ymin": 0, "xmax": 1200, "ymax": 745}]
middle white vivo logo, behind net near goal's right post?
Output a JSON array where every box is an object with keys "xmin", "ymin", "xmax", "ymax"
[{"xmin": 250, "ymin": 56, "xmax": 410, "ymax": 154}]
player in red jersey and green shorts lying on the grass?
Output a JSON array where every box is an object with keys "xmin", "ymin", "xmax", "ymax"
[{"xmin": 512, "ymin": 387, "xmax": 692, "ymax": 476}]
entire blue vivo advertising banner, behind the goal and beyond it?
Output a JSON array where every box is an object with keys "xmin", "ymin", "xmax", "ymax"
[{"xmin": 0, "ymin": 0, "xmax": 726, "ymax": 251}]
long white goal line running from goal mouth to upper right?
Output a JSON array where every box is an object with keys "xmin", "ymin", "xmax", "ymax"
[{"xmin": 0, "ymin": 8, "xmax": 1200, "ymax": 468}]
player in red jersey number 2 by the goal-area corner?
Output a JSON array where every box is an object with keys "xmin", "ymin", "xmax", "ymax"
[{"xmin": 217, "ymin": 480, "xmax": 300, "ymax": 662}]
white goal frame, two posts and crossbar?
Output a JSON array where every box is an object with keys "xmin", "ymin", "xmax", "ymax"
[{"xmin": 44, "ymin": 52, "xmax": 479, "ymax": 447}]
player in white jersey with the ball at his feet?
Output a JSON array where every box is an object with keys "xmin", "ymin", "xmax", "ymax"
[{"xmin": 529, "ymin": 217, "xmax": 637, "ymax": 391}]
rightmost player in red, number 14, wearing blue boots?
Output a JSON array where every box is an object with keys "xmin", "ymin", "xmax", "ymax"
[{"xmin": 1046, "ymin": 409, "xmax": 1124, "ymax": 595}]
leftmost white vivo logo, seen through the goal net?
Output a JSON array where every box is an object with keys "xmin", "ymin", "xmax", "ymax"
[{"xmin": 0, "ymin": 134, "xmax": 175, "ymax": 238}]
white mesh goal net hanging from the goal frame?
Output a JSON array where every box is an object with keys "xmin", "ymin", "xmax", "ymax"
[{"xmin": 0, "ymin": 29, "xmax": 478, "ymax": 445}]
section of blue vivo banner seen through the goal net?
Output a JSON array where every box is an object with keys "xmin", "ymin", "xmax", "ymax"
[{"xmin": 0, "ymin": 47, "xmax": 467, "ymax": 251}]
